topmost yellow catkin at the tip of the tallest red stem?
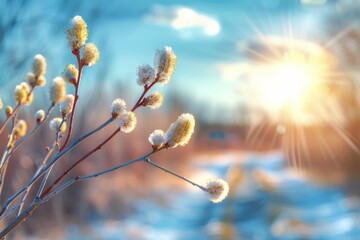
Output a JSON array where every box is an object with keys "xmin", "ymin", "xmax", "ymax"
[{"xmin": 66, "ymin": 16, "xmax": 88, "ymax": 52}]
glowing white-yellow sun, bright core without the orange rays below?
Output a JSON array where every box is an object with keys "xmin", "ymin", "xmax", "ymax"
[{"xmin": 239, "ymin": 38, "xmax": 342, "ymax": 125}]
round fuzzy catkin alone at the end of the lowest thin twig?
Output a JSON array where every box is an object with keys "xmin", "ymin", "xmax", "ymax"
[{"xmin": 206, "ymin": 178, "xmax": 229, "ymax": 203}]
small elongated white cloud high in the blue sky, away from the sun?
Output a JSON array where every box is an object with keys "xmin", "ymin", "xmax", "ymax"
[{"xmin": 145, "ymin": 5, "xmax": 221, "ymax": 36}]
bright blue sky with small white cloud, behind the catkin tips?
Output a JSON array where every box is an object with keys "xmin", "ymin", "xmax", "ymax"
[{"xmin": 0, "ymin": 0, "xmax": 351, "ymax": 123}]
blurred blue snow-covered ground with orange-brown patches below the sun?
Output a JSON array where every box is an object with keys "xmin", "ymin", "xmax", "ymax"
[{"xmin": 66, "ymin": 153, "xmax": 360, "ymax": 240}]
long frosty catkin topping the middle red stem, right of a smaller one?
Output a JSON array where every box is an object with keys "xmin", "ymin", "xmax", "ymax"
[{"xmin": 154, "ymin": 46, "xmax": 176, "ymax": 85}]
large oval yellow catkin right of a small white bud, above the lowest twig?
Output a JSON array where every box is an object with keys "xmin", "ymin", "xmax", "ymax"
[{"xmin": 165, "ymin": 113, "xmax": 195, "ymax": 147}]
